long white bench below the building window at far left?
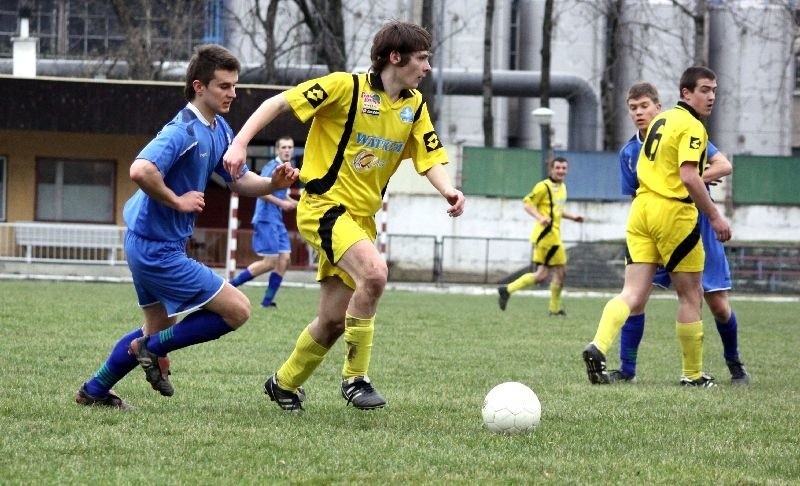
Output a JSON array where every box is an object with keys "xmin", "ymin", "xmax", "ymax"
[{"xmin": 14, "ymin": 221, "xmax": 125, "ymax": 265}]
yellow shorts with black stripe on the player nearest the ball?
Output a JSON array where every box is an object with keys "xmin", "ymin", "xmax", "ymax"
[{"xmin": 297, "ymin": 192, "xmax": 377, "ymax": 289}]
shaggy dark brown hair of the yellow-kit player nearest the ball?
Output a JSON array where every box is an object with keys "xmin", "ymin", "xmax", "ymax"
[{"xmin": 369, "ymin": 20, "xmax": 433, "ymax": 73}]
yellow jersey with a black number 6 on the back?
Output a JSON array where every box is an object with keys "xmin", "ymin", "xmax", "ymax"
[{"xmin": 636, "ymin": 101, "xmax": 708, "ymax": 202}]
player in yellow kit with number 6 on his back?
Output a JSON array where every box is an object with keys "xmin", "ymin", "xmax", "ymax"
[{"xmin": 583, "ymin": 66, "xmax": 731, "ymax": 388}]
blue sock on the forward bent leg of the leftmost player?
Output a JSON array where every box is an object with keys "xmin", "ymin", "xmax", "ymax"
[{"xmin": 147, "ymin": 310, "xmax": 233, "ymax": 356}]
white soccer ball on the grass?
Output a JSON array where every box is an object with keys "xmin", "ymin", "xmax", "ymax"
[{"xmin": 482, "ymin": 381, "xmax": 542, "ymax": 434}]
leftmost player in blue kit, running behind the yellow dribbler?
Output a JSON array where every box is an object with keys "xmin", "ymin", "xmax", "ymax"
[{"xmin": 75, "ymin": 45, "xmax": 298, "ymax": 410}]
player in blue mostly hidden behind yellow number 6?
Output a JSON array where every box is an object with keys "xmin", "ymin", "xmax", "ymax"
[{"xmin": 609, "ymin": 83, "xmax": 750, "ymax": 385}]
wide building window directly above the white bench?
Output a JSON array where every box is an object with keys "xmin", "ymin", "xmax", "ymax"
[{"xmin": 36, "ymin": 158, "xmax": 117, "ymax": 223}]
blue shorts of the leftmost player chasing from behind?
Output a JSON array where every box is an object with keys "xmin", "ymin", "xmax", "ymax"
[{"xmin": 125, "ymin": 231, "xmax": 225, "ymax": 316}]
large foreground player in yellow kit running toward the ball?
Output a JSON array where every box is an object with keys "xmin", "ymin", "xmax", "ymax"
[{"xmin": 224, "ymin": 22, "xmax": 464, "ymax": 411}]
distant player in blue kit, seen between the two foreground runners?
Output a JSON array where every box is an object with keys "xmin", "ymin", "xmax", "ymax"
[{"xmin": 231, "ymin": 137, "xmax": 297, "ymax": 308}]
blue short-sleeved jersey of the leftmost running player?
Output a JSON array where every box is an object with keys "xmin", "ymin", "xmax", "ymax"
[{"xmin": 123, "ymin": 103, "xmax": 248, "ymax": 241}]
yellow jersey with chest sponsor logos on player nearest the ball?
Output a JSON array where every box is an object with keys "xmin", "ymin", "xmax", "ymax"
[{"xmin": 284, "ymin": 72, "xmax": 448, "ymax": 216}]
